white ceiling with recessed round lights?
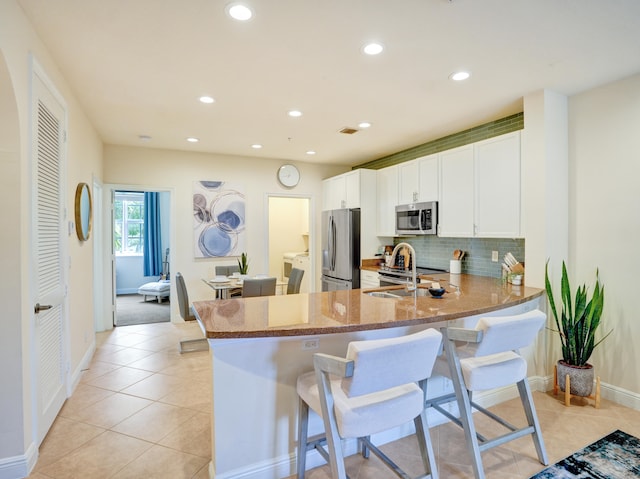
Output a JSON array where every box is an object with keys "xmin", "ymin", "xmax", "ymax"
[{"xmin": 18, "ymin": 0, "xmax": 640, "ymax": 165}]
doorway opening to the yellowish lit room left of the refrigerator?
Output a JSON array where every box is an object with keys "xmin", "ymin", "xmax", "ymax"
[{"xmin": 269, "ymin": 196, "xmax": 314, "ymax": 293}]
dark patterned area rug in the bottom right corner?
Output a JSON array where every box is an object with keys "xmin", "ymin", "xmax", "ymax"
[{"xmin": 530, "ymin": 430, "xmax": 640, "ymax": 479}]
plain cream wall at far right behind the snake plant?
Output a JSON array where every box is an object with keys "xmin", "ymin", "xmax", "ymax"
[{"xmin": 569, "ymin": 75, "xmax": 640, "ymax": 400}]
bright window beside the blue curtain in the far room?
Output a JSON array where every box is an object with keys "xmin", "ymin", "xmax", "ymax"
[{"xmin": 113, "ymin": 191, "xmax": 144, "ymax": 255}]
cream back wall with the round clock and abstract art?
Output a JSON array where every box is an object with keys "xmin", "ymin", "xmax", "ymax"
[{"xmin": 104, "ymin": 145, "xmax": 345, "ymax": 321}]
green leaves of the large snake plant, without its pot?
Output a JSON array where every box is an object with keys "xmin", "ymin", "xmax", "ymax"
[{"xmin": 544, "ymin": 261, "xmax": 611, "ymax": 366}]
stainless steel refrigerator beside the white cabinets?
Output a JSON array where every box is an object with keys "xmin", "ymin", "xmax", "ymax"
[{"xmin": 322, "ymin": 208, "xmax": 360, "ymax": 291}]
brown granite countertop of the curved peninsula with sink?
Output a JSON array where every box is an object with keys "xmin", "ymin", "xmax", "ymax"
[{"xmin": 193, "ymin": 274, "xmax": 544, "ymax": 339}]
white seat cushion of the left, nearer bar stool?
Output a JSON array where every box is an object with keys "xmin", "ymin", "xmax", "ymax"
[{"xmin": 297, "ymin": 371, "xmax": 424, "ymax": 437}]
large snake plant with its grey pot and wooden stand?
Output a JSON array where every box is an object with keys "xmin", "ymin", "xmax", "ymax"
[{"xmin": 544, "ymin": 261, "xmax": 611, "ymax": 406}]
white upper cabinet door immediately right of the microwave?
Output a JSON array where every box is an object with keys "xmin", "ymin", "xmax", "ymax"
[{"xmin": 438, "ymin": 145, "xmax": 474, "ymax": 237}]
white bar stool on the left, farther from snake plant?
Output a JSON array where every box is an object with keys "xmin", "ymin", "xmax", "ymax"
[{"xmin": 296, "ymin": 328, "xmax": 442, "ymax": 479}]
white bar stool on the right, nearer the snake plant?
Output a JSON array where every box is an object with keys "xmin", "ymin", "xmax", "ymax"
[{"xmin": 426, "ymin": 310, "xmax": 549, "ymax": 479}]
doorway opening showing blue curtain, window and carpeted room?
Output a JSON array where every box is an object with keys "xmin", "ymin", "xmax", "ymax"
[{"xmin": 112, "ymin": 188, "xmax": 171, "ymax": 326}]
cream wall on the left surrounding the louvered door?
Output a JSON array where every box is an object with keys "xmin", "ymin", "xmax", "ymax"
[{"xmin": 0, "ymin": 0, "xmax": 102, "ymax": 477}]
